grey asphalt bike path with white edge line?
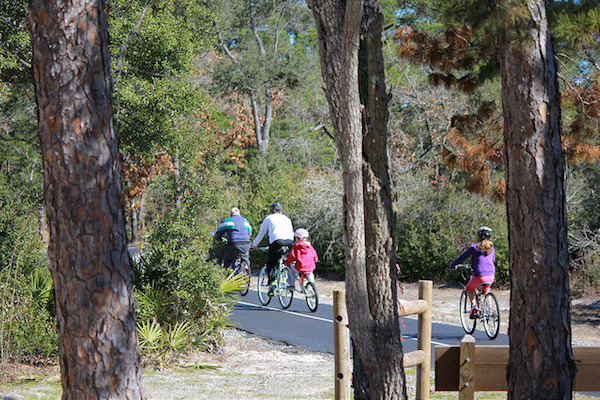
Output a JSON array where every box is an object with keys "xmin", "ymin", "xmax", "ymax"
[{"xmin": 232, "ymin": 290, "xmax": 508, "ymax": 362}]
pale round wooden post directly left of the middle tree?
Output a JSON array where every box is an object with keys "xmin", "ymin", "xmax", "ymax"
[{"xmin": 333, "ymin": 290, "xmax": 351, "ymax": 400}]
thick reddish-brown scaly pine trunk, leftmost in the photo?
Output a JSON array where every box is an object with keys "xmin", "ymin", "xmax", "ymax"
[{"xmin": 29, "ymin": 0, "xmax": 143, "ymax": 400}]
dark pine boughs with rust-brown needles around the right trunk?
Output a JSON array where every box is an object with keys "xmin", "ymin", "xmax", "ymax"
[{"xmin": 394, "ymin": 0, "xmax": 600, "ymax": 201}]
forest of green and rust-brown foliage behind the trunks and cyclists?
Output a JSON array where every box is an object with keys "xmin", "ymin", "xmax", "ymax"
[{"xmin": 0, "ymin": 0, "xmax": 600, "ymax": 362}]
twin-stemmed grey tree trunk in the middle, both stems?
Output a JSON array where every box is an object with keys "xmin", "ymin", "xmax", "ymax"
[{"xmin": 309, "ymin": 0, "xmax": 406, "ymax": 399}]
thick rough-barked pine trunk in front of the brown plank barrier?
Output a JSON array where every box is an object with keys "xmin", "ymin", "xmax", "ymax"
[{"xmin": 501, "ymin": 0, "xmax": 576, "ymax": 399}]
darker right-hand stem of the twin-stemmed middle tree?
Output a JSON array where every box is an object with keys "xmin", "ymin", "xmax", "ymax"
[{"xmin": 355, "ymin": 0, "xmax": 406, "ymax": 399}]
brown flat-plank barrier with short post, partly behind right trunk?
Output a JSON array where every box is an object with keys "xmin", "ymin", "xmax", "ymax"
[{"xmin": 435, "ymin": 335, "xmax": 600, "ymax": 400}]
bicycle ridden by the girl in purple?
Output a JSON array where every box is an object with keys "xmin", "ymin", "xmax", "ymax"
[{"xmin": 457, "ymin": 264, "xmax": 500, "ymax": 340}]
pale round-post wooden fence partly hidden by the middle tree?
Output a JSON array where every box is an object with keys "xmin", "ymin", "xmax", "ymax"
[{"xmin": 333, "ymin": 281, "xmax": 433, "ymax": 400}]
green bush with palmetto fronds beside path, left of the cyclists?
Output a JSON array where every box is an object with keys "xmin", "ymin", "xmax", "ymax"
[{"xmin": 134, "ymin": 219, "xmax": 237, "ymax": 360}]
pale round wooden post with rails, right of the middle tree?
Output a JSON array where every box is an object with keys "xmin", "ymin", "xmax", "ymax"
[{"xmin": 416, "ymin": 281, "xmax": 433, "ymax": 400}]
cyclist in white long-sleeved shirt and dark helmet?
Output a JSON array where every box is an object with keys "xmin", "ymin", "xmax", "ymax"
[{"xmin": 251, "ymin": 202, "xmax": 294, "ymax": 294}]
